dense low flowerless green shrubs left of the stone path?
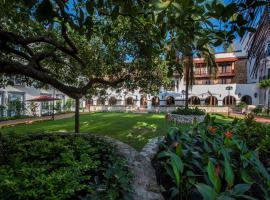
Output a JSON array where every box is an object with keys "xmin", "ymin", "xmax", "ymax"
[{"xmin": 0, "ymin": 135, "xmax": 131, "ymax": 200}]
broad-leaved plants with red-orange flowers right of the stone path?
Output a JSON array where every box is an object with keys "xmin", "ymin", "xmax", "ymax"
[{"xmin": 154, "ymin": 118, "xmax": 270, "ymax": 200}]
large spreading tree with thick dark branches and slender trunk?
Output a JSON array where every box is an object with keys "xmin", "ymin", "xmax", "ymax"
[{"xmin": 0, "ymin": 0, "xmax": 169, "ymax": 132}]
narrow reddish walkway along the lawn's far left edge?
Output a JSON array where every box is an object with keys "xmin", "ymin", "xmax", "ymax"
[{"xmin": 0, "ymin": 113, "xmax": 74, "ymax": 128}]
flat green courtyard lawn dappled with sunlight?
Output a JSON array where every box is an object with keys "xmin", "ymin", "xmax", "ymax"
[{"xmin": 0, "ymin": 113, "xmax": 190, "ymax": 150}]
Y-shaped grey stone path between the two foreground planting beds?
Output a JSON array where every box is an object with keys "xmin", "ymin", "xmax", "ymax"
[{"xmin": 105, "ymin": 137, "xmax": 164, "ymax": 200}]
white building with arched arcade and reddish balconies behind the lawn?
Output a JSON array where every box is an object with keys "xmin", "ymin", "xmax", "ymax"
[{"xmin": 0, "ymin": 52, "xmax": 270, "ymax": 116}]
